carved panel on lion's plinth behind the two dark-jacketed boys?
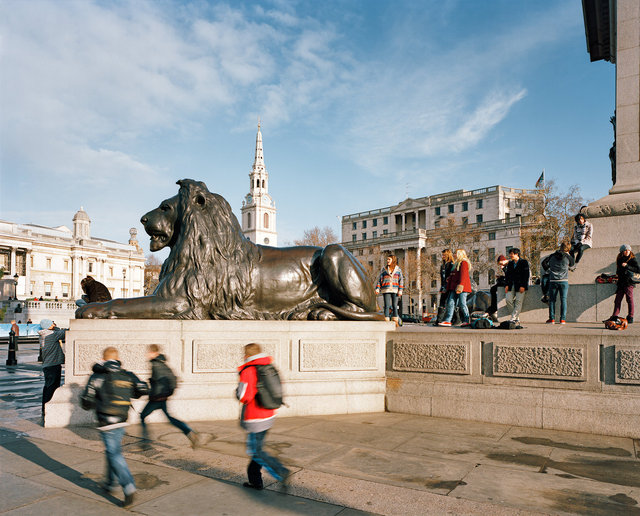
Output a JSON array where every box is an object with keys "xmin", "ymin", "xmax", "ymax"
[{"xmin": 73, "ymin": 339, "xmax": 157, "ymax": 376}]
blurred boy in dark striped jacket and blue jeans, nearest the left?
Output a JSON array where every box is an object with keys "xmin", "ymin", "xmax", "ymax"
[{"xmin": 80, "ymin": 347, "xmax": 149, "ymax": 507}]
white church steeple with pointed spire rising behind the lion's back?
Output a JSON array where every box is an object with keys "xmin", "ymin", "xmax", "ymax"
[{"xmin": 241, "ymin": 123, "xmax": 278, "ymax": 247}]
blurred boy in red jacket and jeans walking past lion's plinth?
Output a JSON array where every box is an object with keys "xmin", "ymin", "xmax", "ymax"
[{"xmin": 236, "ymin": 343, "xmax": 290, "ymax": 489}]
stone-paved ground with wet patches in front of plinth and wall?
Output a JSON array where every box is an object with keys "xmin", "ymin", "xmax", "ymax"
[{"xmin": 0, "ymin": 336, "xmax": 640, "ymax": 516}]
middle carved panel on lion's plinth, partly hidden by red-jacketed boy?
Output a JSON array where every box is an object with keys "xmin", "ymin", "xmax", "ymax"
[{"xmin": 193, "ymin": 337, "xmax": 280, "ymax": 373}]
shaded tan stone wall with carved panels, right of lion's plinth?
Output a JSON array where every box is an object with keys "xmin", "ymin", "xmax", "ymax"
[{"xmin": 387, "ymin": 325, "xmax": 640, "ymax": 438}]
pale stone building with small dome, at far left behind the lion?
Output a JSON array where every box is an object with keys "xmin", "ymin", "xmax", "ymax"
[{"xmin": 0, "ymin": 208, "xmax": 145, "ymax": 301}]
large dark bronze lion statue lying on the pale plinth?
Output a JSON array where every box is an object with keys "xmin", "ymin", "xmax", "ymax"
[{"xmin": 76, "ymin": 179, "xmax": 384, "ymax": 321}]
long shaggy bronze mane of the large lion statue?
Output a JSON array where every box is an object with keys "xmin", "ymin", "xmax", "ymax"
[{"xmin": 154, "ymin": 179, "xmax": 265, "ymax": 319}]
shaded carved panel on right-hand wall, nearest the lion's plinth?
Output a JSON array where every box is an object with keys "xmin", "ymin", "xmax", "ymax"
[{"xmin": 393, "ymin": 341, "xmax": 471, "ymax": 374}]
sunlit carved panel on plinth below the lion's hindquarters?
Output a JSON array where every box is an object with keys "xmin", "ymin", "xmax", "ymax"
[{"xmin": 299, "ymin": 338, "xmax": 378, "ymax": 371}]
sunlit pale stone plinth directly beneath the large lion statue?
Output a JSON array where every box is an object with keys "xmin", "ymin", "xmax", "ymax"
[{"xmin": 45, "ymin": 319, "xmax": 395, "ymax": 427}]
